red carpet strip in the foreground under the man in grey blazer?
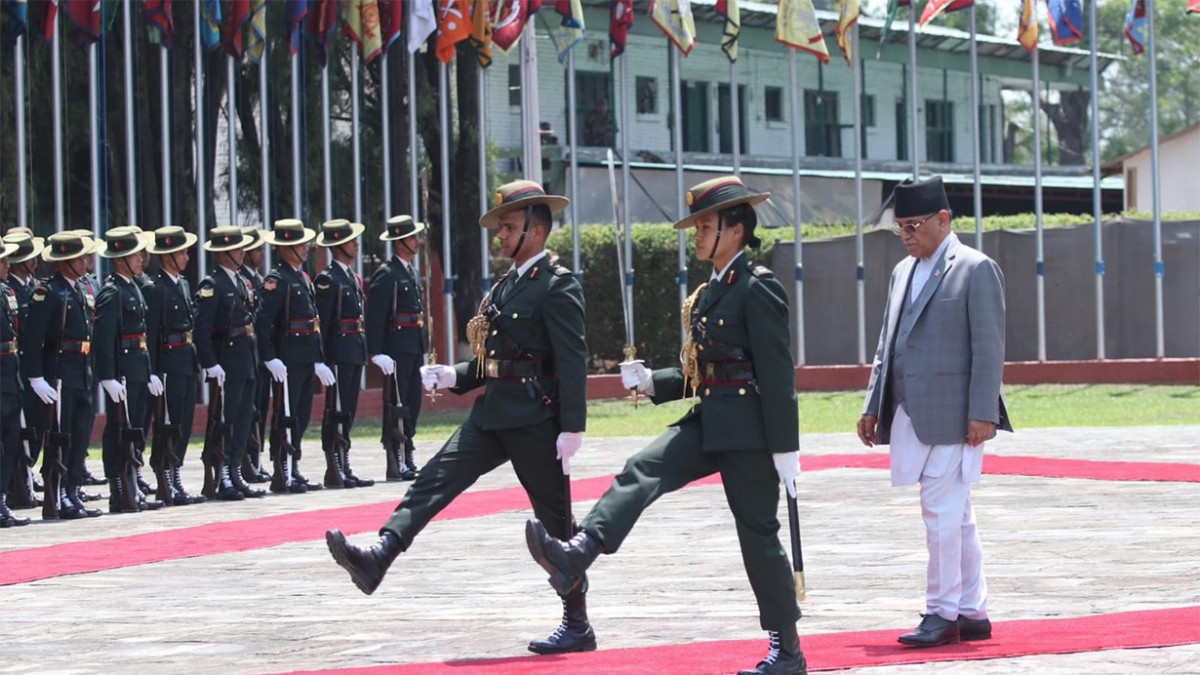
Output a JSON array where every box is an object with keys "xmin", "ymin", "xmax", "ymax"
[{"xmin": 278, "ymin": 607, "xmax": 1200, "ymax": 675}]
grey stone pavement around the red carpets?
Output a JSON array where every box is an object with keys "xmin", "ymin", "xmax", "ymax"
[{"xmin": 0, "ymin": 425, "xmax": 1200, "ymax": 674}]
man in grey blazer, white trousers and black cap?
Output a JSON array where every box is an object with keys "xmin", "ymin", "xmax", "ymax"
[{"xmin": 858, "ymin": 175, "xmax": 1013, "ymax": 647}]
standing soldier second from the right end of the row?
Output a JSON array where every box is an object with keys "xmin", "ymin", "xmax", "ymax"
[{"xmin": 313, "ymin": 219, "xmax": 374, "ymax": 488}]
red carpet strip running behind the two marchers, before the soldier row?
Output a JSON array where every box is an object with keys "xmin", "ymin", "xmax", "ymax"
[{"xmin": 0, "ymin": 453, "xmax": 1200, "ymax": 586}]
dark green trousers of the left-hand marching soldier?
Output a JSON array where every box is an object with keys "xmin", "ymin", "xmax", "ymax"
[{"xmin": 383, "ymin": 418, "xmax": 573, "ymax": 550}]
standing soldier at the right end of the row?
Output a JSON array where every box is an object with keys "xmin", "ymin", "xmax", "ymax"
[{"xmin": 367, "ymin": 216, "xmax": 430, "ymax": 480}]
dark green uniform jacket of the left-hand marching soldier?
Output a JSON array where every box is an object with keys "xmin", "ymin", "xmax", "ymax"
[{"xmin": 452, "ymin": 257, "xmax": 588, "ymax": 431}]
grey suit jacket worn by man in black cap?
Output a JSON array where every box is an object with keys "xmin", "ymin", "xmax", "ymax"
[{"xmin": 863, "ymin": 233, "xmax": 1013, "ymax": 446}]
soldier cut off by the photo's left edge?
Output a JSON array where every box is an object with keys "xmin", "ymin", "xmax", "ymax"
[{"xmin": 0, "ymin": 239, "xmax": 29, "ymax": 527}]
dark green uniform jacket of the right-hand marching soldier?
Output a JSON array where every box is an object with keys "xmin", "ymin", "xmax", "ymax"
[{"xmin": 653, "ymin": 255, "xmax": 800, "ymax": 453}]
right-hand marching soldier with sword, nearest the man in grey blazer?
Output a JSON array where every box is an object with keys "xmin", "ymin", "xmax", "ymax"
[{"xmin": 526, "ymin": 175, "xmax": 806, "ymax": 674}]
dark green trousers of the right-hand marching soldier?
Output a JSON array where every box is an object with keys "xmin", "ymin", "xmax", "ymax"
[{"xmin": 581, "ymin": 417, "xmax": 800, "ymax": 631}]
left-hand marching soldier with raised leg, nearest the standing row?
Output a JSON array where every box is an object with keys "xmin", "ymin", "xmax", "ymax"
[{"xmin": 325, "ymin": 180, "xmax": 596, "ymax": 653}]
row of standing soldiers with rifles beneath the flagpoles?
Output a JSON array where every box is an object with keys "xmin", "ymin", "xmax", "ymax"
[{"xmin": 0, "ymin": 216, "xmax": 428, "ymax": 527}]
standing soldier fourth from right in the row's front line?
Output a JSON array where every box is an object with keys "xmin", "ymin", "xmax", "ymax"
[{"xmin": 194, "ymin": 226, "xmax": 263, "ymax": 501}]
